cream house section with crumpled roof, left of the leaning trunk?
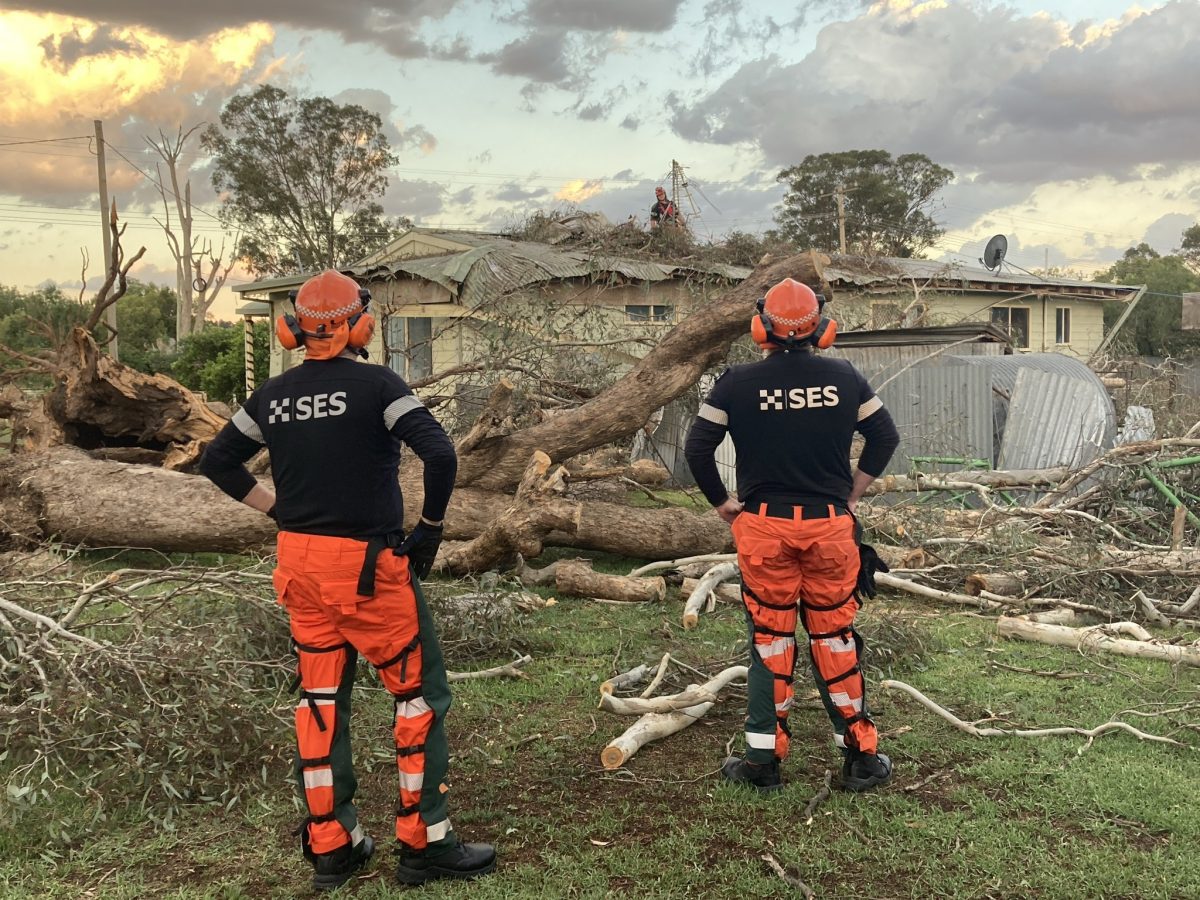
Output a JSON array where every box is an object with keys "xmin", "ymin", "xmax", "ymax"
[{"xmin": 233, "ymin": 228, "xmax": 749, "ymax": 382}]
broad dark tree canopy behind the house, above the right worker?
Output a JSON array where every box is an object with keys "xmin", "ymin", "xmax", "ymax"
[{"xmin": 775, "ymin": 150, "xmax": 954, "ymax": 257}]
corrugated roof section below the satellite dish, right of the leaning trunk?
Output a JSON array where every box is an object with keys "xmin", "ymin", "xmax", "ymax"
[{"xmin": 824, "ymin": 254, "xmax": 1140, "ymax": 299}]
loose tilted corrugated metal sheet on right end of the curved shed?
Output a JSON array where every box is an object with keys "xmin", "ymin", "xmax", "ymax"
[{"xmin": 997, "ymin": 368, "xmax": 1112, "ymax": 469}]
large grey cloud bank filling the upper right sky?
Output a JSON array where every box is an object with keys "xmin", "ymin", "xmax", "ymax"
[{"xmin": 670, "ymin": 0, "xmax": 1200, "ymax": 182}]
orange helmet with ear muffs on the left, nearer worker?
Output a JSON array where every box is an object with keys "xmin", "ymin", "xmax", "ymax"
[{"xmin": 275, "ymin": 269, "xmax": 374, "ymax": 359}]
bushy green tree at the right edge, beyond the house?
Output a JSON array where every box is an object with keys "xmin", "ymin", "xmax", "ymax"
[{"xmin": 1096, "ymin": 241, "xmax": 1200, "ymax": 356}]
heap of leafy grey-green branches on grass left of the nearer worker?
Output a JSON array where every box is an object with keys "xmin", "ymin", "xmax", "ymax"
[{"xmin": 0, "ymin": 551, "xmax": 294, "ymax": 838}]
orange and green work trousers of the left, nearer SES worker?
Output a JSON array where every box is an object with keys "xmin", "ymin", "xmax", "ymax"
[{"xmin": 274, "ymin": 532, "xmax": 456, "ymax": 856}]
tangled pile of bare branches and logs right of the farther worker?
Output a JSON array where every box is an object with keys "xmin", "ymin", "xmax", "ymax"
[{"xmin": 859, "ymin": 437, "xmax": 1200, "ymax": 628}]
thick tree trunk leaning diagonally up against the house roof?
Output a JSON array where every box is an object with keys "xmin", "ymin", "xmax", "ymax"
[{"xmin": 458, "ymin": 252, "xmax": 832, "ymax": 491}]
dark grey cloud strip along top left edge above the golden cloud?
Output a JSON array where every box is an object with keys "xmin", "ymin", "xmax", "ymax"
[{"xmin": 14, "ymin": 0, "xmax": 458, "ymax": 59}]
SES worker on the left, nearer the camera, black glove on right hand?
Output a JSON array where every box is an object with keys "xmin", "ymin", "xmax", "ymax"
[{"xmin": 200, "ymin": 270, "xmax": 496, "ymax": 890}]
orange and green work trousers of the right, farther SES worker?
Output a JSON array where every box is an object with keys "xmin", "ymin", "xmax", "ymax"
[{"xmin": 733, "ymin": 504, "xmax": 878, "ymax": 763}]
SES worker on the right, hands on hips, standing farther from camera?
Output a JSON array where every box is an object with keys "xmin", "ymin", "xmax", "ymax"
[{"xmin": 685, "ymin": 278, "xmax": 900, "ymax": 791}]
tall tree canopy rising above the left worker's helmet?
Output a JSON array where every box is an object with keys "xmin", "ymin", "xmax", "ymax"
[{"xmin": 202, "ymin": 84, "xmax": 397, "ymax": 275}]
